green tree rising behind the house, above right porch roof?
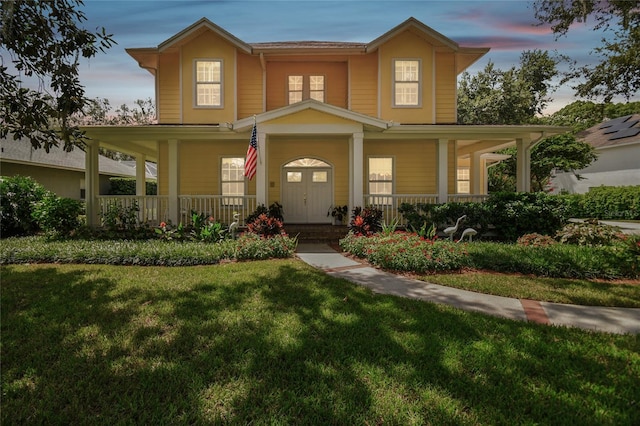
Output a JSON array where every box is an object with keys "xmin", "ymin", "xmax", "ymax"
[{"xmin": 458, "ymin": 50, "xmax": 558, "ymax": 124}]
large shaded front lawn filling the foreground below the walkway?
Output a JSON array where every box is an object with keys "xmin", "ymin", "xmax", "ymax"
[{"xmin": 0, "ymin": 259, "xmax": 640, "ymax": 425}]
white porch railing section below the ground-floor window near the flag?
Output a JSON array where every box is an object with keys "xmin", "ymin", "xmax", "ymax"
[{"xmin": 178, "ymin": 195, "xmax": 257, "ymax": 225}]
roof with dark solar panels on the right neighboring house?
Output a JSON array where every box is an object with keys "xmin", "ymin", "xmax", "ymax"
[{"xmin": 576, "ymin": 114, "xmax": 640, "ymax": 149}]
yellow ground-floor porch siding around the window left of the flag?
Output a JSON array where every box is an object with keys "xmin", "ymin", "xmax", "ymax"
[{"xmin": 179, "ymin": 139, "xmax": 250, "ymax": 195}]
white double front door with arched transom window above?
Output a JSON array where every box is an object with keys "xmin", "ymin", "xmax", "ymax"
[{"xmin": 282, "ymin": 158, "xmax": 333, "ymax": 223}]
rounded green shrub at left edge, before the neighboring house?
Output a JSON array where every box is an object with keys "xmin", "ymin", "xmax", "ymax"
[{"xmin": 0, "ymin": 176, "xmax": 49, "ymax": 238}]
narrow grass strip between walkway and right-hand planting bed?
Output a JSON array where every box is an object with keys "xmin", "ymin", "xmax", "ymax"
[{"xmin": 419, "ymin": 271, "xmax": 640, "ymax": 308}]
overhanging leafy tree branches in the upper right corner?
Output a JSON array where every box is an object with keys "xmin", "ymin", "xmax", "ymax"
[{"xmin": 534, "ymin": 0, "xmax": 640, "ymax": 102}]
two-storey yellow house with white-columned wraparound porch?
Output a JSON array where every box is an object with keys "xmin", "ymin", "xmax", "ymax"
[{"xmin": 84, "ymin": 18, "xmax": 566, "ymax": 223}]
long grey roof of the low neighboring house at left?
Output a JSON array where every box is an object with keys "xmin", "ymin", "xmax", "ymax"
[{"xmin": 0, "ymin": 139, "xmax": 155, "ymax": 178}]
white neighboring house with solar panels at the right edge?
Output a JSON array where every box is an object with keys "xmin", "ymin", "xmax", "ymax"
[{"xmin": 550, "ymin": 114, "xmax": 640, "ymax": 194}]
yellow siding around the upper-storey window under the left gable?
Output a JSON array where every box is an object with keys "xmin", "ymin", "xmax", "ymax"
[{"xmin": 182, "ymin": 32, "xmax": 236, "ymax": 124}]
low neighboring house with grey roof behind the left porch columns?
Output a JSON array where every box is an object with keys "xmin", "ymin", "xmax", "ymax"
[{"xmin": 0, "ymin": 139, "xmax": 152, "ymax": 200}]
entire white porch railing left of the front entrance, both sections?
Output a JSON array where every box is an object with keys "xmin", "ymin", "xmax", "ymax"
[{"xmin": 97, "ymin": 195, "xmax": 257, "ymax": 226}]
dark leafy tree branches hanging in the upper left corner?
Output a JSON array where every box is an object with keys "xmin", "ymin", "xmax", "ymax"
[{"xmin": 0, "ymin": 0, "xmax": 114, "ymax": 151}]
